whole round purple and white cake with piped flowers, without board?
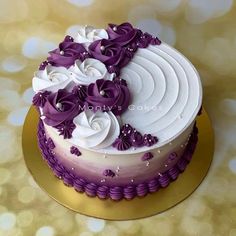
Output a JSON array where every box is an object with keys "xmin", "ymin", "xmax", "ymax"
[{"xmin": 32, "ymin": 23, "xmax": 202, "ymax": 201}]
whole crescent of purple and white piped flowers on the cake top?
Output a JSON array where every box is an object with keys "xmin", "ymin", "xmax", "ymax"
[{"xmin": 33, "ymin": 23, "xmax": 161, "ymax": 150}]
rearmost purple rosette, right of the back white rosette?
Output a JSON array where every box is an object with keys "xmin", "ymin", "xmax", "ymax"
[{"xmin": 107, "ymin": 22, "xmax": 141, "ymax": 46}]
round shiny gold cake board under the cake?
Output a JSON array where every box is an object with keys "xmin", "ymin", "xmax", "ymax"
[{"xmin": 22, "ymin": 107, "xmax": 214, "ymax": 220}]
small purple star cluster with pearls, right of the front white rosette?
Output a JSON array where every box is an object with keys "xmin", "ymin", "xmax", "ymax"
[{"xmin": 112, "ymin": 124, "xmax": 158, "ymax": 151}]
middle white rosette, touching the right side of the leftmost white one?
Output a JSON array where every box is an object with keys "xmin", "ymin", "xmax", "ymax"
[{"xmin": 69, "ymin": 58, "xmax": 110, "ymax": 85}]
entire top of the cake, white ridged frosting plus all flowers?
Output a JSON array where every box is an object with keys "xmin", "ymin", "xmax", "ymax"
[{"xmin": 33, "ymin": 23, "xmax": 202, "ymax": 153}]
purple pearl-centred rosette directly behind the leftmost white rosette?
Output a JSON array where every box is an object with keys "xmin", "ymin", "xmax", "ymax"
[{"xmin": 47, "ymin": 36, "xmax": 88, "ymax": 68}]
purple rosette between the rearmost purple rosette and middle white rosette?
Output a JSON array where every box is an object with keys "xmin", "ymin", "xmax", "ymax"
[{"xmin": 89, "ymin": 39, "xmax": 130, "ymax": 75}]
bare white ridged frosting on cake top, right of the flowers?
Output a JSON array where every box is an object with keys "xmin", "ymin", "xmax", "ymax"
[{"xmin": 120, "ymin": 43, "xmax": 202, "ymax": 146}]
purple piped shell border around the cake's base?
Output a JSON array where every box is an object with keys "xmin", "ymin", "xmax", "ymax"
[{"xmin": 38, "ymin": 121, "xmax": 198, "ymax": 201}]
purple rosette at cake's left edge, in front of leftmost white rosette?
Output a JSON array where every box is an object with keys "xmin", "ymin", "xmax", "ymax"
[{"xmin": 43, "ymin": 89, "xmax": 83, "ymax": 126}]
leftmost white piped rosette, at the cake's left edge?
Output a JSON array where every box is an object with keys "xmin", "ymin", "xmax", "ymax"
[{"xmin": 32, "ymin": 65, "xmax": 72, "ymax": 93}]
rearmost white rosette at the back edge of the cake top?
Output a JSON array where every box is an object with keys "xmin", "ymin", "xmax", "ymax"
[{"xmin": 75, "ymin": 26, "xmax": 108, "ymax": 47}]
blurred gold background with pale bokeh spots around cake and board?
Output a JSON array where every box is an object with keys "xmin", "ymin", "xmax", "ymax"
[{"xmin": 0, "ymin": 0, "xmax": 236, "ymax": 236}]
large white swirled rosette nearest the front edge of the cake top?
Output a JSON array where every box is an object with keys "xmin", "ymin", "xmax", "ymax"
[{"xmin": 71, "ymin": 110, "xmax": 120, "ymax": 149}]
